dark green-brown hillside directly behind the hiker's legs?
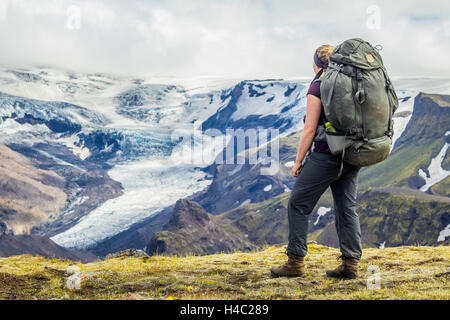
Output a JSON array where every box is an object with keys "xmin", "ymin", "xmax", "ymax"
[{"xmin": 220, "ymin": 188, "xmax": 450, "ymax": 247}]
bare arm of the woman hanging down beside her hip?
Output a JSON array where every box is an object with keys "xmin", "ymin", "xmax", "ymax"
[{"xmin": 292, "ymin": 94, "xmax": 322, "ymax": 177}]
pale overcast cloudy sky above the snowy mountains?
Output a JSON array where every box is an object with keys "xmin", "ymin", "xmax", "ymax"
[{"xmin": 0, "ymin": 0, "xmax": 450, "ymax": 78}]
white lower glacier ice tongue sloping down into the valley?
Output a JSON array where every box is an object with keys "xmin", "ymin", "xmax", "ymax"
[{"xmin": 52, "ymin": 159, "xmax": 211, "ymax": 249}]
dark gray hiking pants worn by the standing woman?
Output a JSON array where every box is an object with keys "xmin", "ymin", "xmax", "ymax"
[{"xmin": 287, "ymin": 152, "xmax": 362, "ymax": 259}]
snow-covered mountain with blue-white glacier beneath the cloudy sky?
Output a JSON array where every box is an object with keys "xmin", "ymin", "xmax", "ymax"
[{"xmin": 0, "ymin": 68, "xmax": 450, "ymax": 249}]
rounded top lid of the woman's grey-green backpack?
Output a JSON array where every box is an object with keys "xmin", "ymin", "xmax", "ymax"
[{"xmin": 330, "ymin": 38, "xmax": 384, "ymax": 70}]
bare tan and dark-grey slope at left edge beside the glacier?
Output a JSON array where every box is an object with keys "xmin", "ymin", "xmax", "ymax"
[{"xmin": 0, "ymin": 144, "xmax": 122, "ymax": 236}]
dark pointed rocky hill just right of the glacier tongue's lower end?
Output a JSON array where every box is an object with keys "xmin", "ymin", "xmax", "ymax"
[{"xmin": 146, "ymin": 199, "xmax": 256, "ymax": 255}]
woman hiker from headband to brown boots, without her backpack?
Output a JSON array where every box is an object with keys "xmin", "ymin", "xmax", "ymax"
[{"xmin": 271, "ymin": 45, "xmax": 362, "ymax": 278}]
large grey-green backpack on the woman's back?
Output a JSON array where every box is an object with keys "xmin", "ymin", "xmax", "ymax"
[{"xmin": 320, "ymin": 39, "xmax": 398, "ymax": 171}]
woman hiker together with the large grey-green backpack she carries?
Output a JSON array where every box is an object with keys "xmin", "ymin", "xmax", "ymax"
[{"xmin": 271, "ymin": 38, "xmax": 398, "ymax": 279}]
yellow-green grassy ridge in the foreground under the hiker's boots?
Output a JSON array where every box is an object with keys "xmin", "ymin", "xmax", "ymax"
[{"xmin": 0, "ymin": 244, "xmax": 450, "ymax": 303}]
